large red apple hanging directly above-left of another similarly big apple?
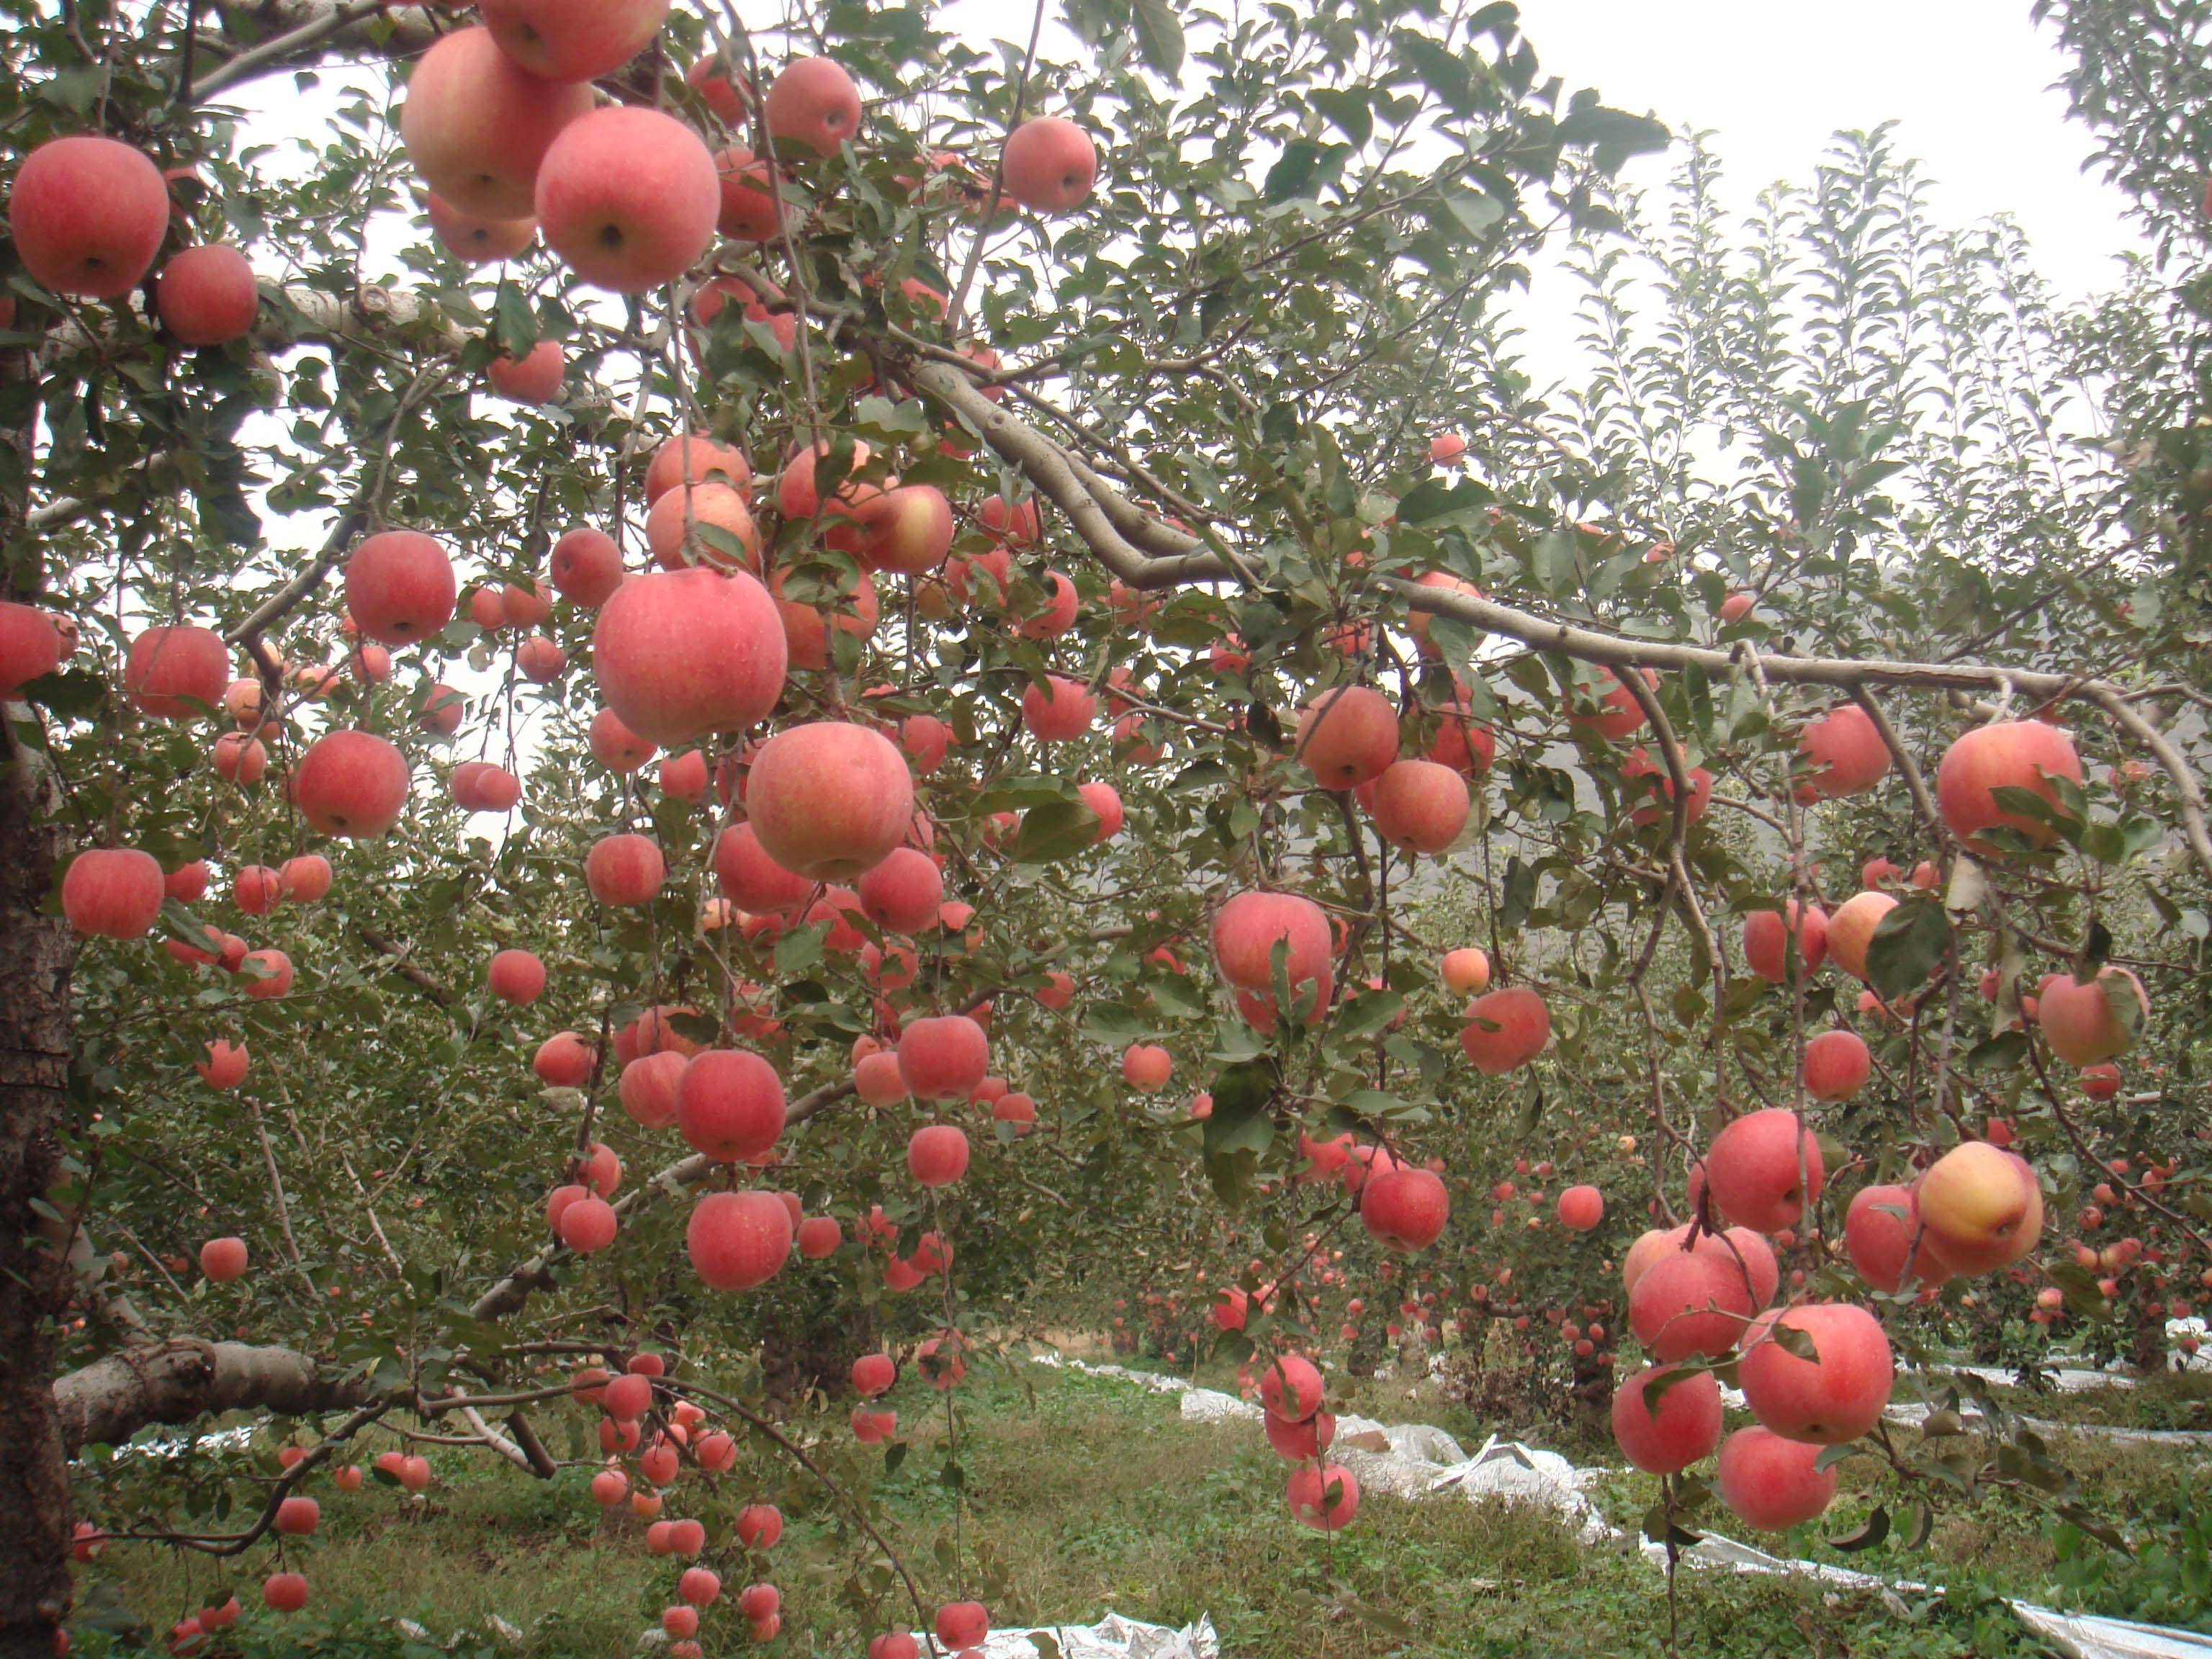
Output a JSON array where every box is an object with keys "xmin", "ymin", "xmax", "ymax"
[{"xmin": 590, "ymin": 569, "xmax": 786, "ymax": 747}]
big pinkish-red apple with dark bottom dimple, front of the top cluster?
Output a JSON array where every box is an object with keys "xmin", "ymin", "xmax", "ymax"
[{"xmin": 531, "ymin": 107, "xmax": 721, "ymax": 295}]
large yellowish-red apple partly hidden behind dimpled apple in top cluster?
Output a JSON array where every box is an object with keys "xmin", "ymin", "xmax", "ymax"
[{"xmin": 400, "ymin": 29, "xmax": 593, "ymax": 219}]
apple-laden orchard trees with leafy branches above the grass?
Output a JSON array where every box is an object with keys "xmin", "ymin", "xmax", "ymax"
[{"xmin": 0, "ymin": 0, "xmax": 2212, "ymax": 1659}]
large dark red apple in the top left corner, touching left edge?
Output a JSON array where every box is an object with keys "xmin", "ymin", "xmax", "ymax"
[{"xmin": 6, "ymin": 132, "xmax": 168, "ymax": 299}]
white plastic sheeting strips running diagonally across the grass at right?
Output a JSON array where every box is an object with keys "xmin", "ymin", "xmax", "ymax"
[{"xmin": 1030, "ymin": 1344, "xmax": 2212, "ymax": 1659}]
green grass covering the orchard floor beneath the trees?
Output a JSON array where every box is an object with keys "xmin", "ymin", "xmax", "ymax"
[{"xmin": 80, "ymin": 1360, "xmax": 2194, "ymax": 1659}]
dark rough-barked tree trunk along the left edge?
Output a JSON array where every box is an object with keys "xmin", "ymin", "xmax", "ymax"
[{"xmin": 0, "ymin": 320, "xmax": 75, "ymax": 1659}]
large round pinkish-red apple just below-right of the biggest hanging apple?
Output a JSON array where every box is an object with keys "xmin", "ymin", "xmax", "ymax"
[{"xmin": 732, "ymin": 721, "xmax": 914, "ymax": 896}]
